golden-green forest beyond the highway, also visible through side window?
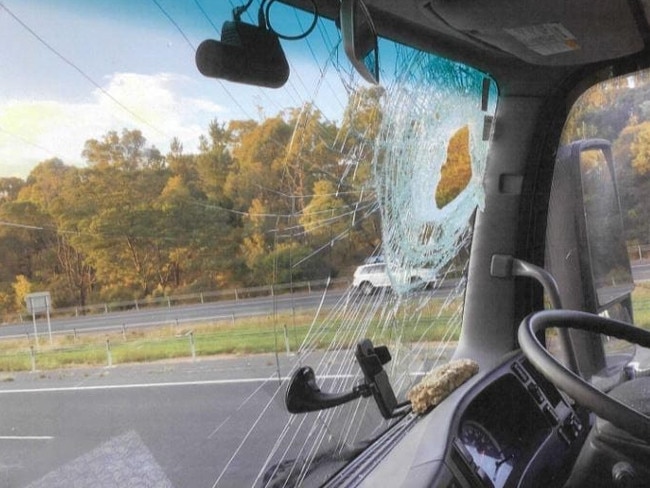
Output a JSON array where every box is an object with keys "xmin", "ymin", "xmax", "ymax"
[{"xmin": 0, "ymin": 71, "xmax": 650, "ymax": 320}]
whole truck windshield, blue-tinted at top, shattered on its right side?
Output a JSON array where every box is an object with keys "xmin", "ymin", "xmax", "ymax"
[{"xmin": 0, "ymin": 0, "xmax": 497, "ymax": 487}]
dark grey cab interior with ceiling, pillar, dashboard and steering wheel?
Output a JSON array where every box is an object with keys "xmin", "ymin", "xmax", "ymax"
[{"xmin": 268, "ymin": 0, "xmax": 650, "ymax": 487}]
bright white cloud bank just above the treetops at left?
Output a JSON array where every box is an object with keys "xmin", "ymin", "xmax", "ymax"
[{"xmin": 0, "ymin": 73, "xmax": 226, "ymax": 178}]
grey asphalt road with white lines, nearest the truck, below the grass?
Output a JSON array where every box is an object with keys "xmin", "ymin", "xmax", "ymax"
[{"xmin": 0, "ymin": 356, "xmax": 293, "ymax": 488}]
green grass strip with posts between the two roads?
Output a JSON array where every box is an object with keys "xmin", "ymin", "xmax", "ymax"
[{"xmin": 0, "ymin": 299, "xmax": 457, "ymax": 372}]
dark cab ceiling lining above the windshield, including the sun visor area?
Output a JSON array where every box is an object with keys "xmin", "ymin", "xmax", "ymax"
[{"xmin": 281, "ymin": 0, "xmax": 650, "ymax": 96}]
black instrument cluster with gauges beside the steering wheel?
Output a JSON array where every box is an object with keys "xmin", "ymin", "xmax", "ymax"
[{"xmin": 447, "ymin": 356, "xmax": 588, "ymax": 488}]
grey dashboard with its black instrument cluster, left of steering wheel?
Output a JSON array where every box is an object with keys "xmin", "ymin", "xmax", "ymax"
[{"xmin": 326, "ymin": 353, "xmax": 590, "ymax": 488}]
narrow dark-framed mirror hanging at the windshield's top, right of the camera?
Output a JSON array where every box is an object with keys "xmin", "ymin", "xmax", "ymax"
[{"xmin": 340, "ymin": 0, "xmax": 379, "ymax": 84}]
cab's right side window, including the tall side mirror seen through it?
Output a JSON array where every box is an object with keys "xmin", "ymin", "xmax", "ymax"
[{"xmin": 546, "ymin": 71, "xmax": 650, "ymax": 374}]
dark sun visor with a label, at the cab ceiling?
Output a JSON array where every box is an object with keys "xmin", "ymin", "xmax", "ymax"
[{"xmin": 421, "ymin": 0, "xmax": 643, "ymax": 66}]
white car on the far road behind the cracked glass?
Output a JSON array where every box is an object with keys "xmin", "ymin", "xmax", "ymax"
[{"xmin": 352, "ymin": 263, "xmax": 436, "ymax": 295}]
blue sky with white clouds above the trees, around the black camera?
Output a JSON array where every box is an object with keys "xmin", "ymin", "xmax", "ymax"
[{"xmin": 0, "ymin": 0, "xmax": 344, "ymax": 179}]
